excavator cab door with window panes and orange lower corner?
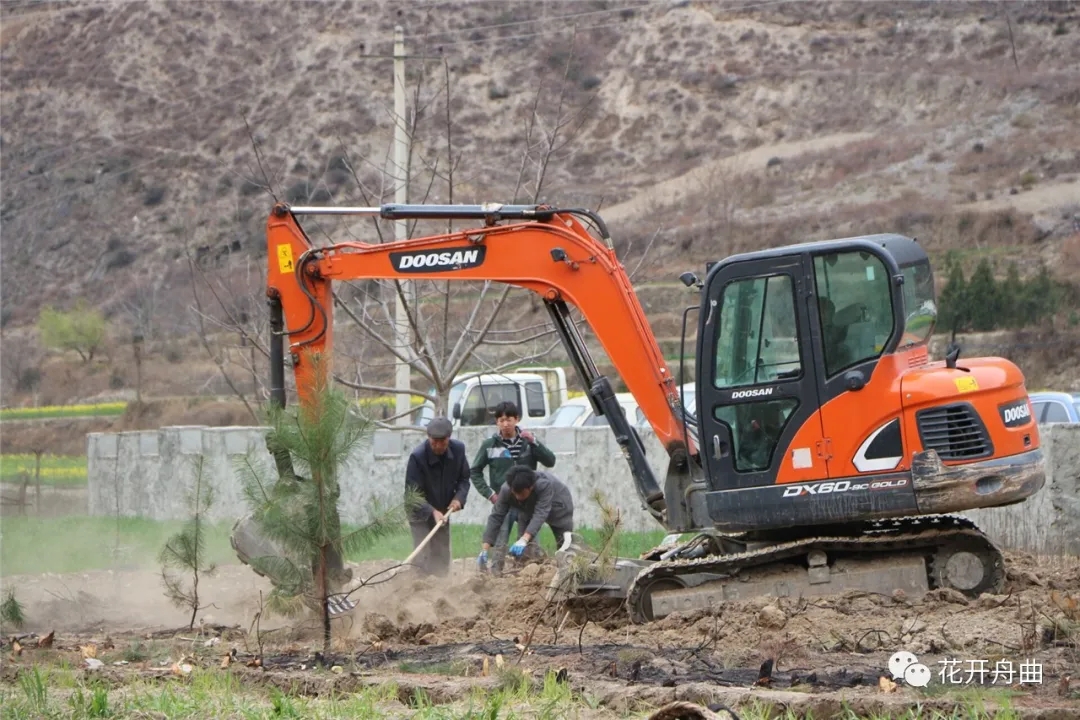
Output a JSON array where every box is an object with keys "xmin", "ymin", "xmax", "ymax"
[{"xmin": 697, "ymin": 255, "xmax": 828, "ymax": 496}]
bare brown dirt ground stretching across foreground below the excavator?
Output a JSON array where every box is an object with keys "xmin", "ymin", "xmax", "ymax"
[{"xmin": 0, "ymin": 554, "xmax": 1080, "ymax": 718}]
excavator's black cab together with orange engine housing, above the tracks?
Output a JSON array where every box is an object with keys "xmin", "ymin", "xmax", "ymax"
[{"xmin": 682, "ymin": 234, "xmax": 1038, "ymax": 534}]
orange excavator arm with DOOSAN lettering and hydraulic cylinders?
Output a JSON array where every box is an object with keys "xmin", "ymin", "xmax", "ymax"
[{"xmin": 267, "ymin": 203, "xmax": 696, "ymax": 525}]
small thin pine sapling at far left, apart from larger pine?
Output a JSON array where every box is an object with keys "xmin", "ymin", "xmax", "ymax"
[{"xmin": 159, "ymin": 456, "xmax": 217, "ymax": 628}]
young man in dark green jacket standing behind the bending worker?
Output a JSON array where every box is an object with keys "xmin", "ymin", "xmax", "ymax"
[{"xmin": 472, "ymin": 400, "xmax": 555, "ymax": 573}]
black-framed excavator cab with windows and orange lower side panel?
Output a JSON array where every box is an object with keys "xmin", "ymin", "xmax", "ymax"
[{"xmin": 697, "ymin": 235, "xmax": 936, "ymax": 530}]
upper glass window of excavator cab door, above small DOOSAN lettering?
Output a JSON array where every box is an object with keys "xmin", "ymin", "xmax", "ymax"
[{"xmin": 713, "ymin": 275, "xmax": 802, "ymax": 389}]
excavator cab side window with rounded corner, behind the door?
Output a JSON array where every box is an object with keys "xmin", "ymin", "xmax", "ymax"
[{"xmin": 814, "ymin": 250, "xmax": 894, "ymax": 377}]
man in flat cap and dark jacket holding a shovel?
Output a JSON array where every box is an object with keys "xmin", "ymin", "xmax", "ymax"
[{"xmin": 405, "ymin": 418, "xmax": 469, "ymax": 575}]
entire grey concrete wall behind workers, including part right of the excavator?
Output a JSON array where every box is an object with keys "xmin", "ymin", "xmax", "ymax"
[{"xmin": 86, "ymin": 425, "xmax": 1080, "ymax": 556}]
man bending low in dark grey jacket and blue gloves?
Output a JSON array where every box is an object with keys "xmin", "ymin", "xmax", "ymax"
[{"xmin": 476, "ymin": 465, "xmax": 573, "ymax": 570}]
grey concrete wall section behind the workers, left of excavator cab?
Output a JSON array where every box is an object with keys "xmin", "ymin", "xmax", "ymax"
[{"xmin": 86, "ymin": 426, "xmax": 667, "ymax": 531}]
